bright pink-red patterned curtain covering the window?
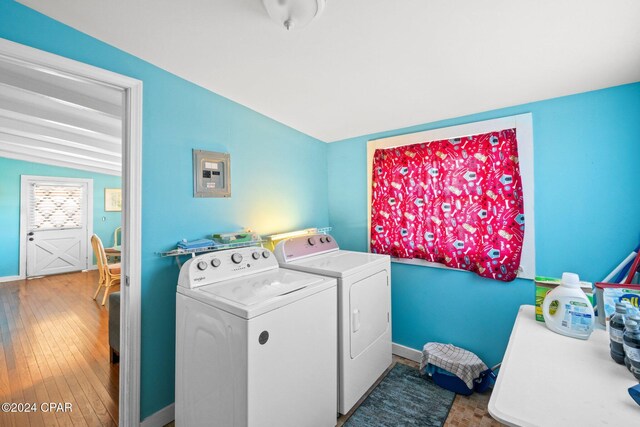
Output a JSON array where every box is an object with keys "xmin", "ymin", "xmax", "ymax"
[{"xmin": 371, "ymin": 129, "xmax": 524, "ymax": 281}]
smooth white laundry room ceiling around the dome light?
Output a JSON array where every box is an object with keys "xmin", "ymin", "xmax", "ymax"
[{"xmin": 19, "ymin": 0, "xmax": 640, "ymax": 142}]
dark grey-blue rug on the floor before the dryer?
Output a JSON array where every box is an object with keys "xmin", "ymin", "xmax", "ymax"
[{"xmin": 344, "ymin": 363, "xmax": 456, "ymax": 427}]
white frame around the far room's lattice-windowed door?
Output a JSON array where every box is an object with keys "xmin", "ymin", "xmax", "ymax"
[{"xmin": 18, "ymin": 175, "xmax": 93, "ymax": 279}]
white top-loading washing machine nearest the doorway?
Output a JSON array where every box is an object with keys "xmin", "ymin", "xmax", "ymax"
[{"xmin": 175, "ymin": 248, "xmax": 338, "ymax": 427}]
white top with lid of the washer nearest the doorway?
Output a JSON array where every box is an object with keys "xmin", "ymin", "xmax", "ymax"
[{"xmin": 178, "ymin": 269, "xmax": 336, "ymax": 319}]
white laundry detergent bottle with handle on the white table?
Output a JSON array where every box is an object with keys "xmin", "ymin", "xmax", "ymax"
[{"xmin": 542, "ymin": 273, "xmax": 594, "ymax": 340}]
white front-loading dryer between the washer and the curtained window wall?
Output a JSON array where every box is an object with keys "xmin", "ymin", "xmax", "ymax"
[{"xmin": 274, "ymin": 234, "xmax": 392, "ymax": 414}]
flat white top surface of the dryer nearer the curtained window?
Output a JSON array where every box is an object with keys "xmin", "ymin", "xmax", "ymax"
[{"xmin": 281, "ymin": 250, "xmax": 391, "ymax": 277}]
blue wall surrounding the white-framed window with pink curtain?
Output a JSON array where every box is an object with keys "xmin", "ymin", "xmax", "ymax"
[{"xmin": 328, "ymin": 83, "xmax": 640, "ymax": 365}]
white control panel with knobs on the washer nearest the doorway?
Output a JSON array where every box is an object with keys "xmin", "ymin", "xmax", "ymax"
[{"xmin": 178, "ymin": 247, "xmax": 278, "ymax": 289}]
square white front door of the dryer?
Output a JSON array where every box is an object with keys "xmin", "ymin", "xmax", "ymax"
[{"xmin": 349, "ymin": 270, "xmax": 390, "ymax": 359}]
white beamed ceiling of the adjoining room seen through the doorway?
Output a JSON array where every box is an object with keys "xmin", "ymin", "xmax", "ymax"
[{"xmin": 0, "ymin": 55, "xmax": 123, "ymax": 175}]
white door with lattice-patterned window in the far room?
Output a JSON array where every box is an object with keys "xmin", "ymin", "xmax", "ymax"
[{"xmin": 22, "ymin": 178, "xmax": 92, "ymax": 277}]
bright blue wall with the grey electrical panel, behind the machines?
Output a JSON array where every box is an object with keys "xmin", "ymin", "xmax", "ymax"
[{"xmin": 0, "ymin": 0, "xmax": 328, "ymax": 418}]
